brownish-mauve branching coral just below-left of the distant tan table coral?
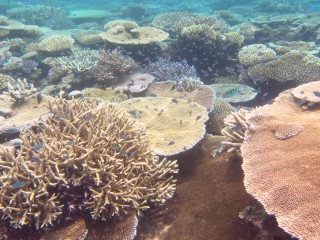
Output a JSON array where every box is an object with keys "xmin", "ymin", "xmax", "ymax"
[{"xmin": 90, "ymin": 49, "xmax": 139, "ymax": 82}]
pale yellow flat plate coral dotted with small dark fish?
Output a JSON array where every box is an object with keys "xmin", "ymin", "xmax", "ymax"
[{"xmin": 119, "ymin": 97, "xmax": 208, "ymax": 156}]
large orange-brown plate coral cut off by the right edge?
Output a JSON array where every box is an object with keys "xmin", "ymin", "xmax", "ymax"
[{"xmin": 241, "ymin": 84, "xmax": 320, "ymax": 240}]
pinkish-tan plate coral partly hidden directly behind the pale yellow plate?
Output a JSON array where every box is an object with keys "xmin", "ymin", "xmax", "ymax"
[{"xmin": 146, "ymin": 81, "xmax": 215, "ymax": 112}]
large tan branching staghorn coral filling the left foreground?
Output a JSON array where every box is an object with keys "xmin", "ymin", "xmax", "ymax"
[{"xmin": 0, "ymin": 98, "xmax": 177, "ymax": 228}]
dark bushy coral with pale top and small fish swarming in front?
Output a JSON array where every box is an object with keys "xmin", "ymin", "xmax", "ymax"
[{"xmin": 173, "ymin": 24, "xmax": 243, "ymax": 80}]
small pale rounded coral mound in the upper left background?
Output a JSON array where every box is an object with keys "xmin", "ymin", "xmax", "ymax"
[{"xmin": 39, "ymin": 35, "xmax": 74, "ymax": 52}]
